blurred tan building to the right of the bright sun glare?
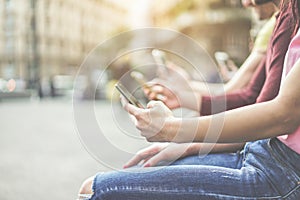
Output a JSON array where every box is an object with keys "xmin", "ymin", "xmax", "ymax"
[{"xmin": 153, "ymin": 0, "xmax": 252, "ymax": 63}]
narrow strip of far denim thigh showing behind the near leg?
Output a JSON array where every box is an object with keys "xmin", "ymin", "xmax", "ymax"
[{"xmin": 171, "ymin": 152, "xmax": 243, "ymax": 169}]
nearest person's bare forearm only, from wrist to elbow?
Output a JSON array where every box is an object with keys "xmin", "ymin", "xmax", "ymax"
[{"xmin": 170, "ymin": 97, "xmax": 296, "ymax": 143}]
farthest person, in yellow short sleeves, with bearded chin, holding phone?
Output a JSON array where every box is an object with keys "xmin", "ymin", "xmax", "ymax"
[{"xmin": 144, "ymin": 1, "xmax": 278, "ymax": 98}]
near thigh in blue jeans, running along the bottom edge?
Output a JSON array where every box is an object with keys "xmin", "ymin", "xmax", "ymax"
[{"xmin": 91, "ymin": 165, "xmax": 276, "ymax": 200}]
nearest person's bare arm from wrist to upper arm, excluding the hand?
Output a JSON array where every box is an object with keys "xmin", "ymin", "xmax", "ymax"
[{"xmin": 170, "ymin": 60, "xmax": 300, "ymax": 143}]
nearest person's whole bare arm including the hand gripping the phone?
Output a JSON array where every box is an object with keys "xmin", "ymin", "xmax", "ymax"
[{"xmin": 124, "ymin": 60, "xmax": 300, "ymax": 143}]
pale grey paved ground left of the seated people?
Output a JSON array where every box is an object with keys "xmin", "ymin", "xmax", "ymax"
[{"xmin": 0, "ymin": 99, "xmax": 147, "ymax": 200}]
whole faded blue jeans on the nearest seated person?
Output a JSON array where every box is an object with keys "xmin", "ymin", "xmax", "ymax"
[{"xmin": 91, "ymin": 139, "xmax": 300, "ymax": 200}]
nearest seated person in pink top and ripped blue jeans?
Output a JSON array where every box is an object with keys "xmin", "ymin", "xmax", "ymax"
[{"xmin": 80, "ymin": 0, "xmax": 300, "ymax": 200}]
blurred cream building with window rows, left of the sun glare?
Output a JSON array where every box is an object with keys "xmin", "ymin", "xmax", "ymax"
[{"xmin": 0, "ymin": 0, "xmax": 127, "ymax": 88}]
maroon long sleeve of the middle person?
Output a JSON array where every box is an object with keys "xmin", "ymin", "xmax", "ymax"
[{"xmin": 200, "ymin": 0, "xmax": 298, "ymax": 115}]
